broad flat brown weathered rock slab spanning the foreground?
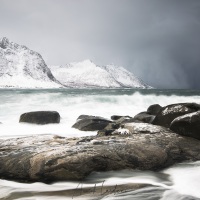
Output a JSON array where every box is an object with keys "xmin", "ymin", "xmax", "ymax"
[{"xmin": 0, "ymin": 128, "xmax": 200, "ymax": 182}]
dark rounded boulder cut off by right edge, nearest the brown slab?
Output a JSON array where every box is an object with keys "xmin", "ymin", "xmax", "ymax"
[{"xmin": 170, "ymin": 111, "xmax": 200, "ymax": 140}]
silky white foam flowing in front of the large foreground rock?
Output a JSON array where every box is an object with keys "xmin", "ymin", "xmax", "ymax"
[{"xmin": 0, "ymin": 162, "xmax": 200, "ymax": 200}]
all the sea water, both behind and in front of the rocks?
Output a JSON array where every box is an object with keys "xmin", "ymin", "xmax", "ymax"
[{"xmin": 0, "ymin": 89, "xmax": 200, "ymax": 200}]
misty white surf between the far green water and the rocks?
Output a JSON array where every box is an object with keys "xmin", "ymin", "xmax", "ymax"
[{"xmin": 0, "ymin": 90, "xmax": 200, "ymax": 137}]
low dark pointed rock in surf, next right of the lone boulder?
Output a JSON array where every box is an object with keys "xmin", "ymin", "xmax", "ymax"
[{"xmin": 72, "ymin": 115, "xmax": 112, "ymax": 131}]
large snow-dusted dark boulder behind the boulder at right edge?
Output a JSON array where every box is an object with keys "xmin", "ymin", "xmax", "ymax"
[{"xmin": 152, "ymin": 103, "xmax": 200, "ymax": 128}]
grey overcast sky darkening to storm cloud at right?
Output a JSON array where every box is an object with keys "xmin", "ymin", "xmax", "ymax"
[{"xmin": 0, "ymin": 0, "xmax": 200, "ymax": 89}]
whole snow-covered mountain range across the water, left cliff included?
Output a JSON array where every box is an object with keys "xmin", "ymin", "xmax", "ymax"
[{"xmin": 0, "ymin": 37, "xmax": 151, "ymax": 88}]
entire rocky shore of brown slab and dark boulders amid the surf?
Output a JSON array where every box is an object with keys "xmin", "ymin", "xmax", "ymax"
[{"xmin": 0, "ymin": 103, "xmax": 200, "ymax": 183}]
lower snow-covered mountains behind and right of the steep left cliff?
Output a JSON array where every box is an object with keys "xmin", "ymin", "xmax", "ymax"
[{"xmin": 50, "ymin": 60, "xmax": 151, "ymax": 88}]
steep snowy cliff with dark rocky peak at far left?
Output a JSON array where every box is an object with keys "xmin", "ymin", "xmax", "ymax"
[{"xmin": 0, "ymin": 37, "xmax": 61, "ymax": 88}]
